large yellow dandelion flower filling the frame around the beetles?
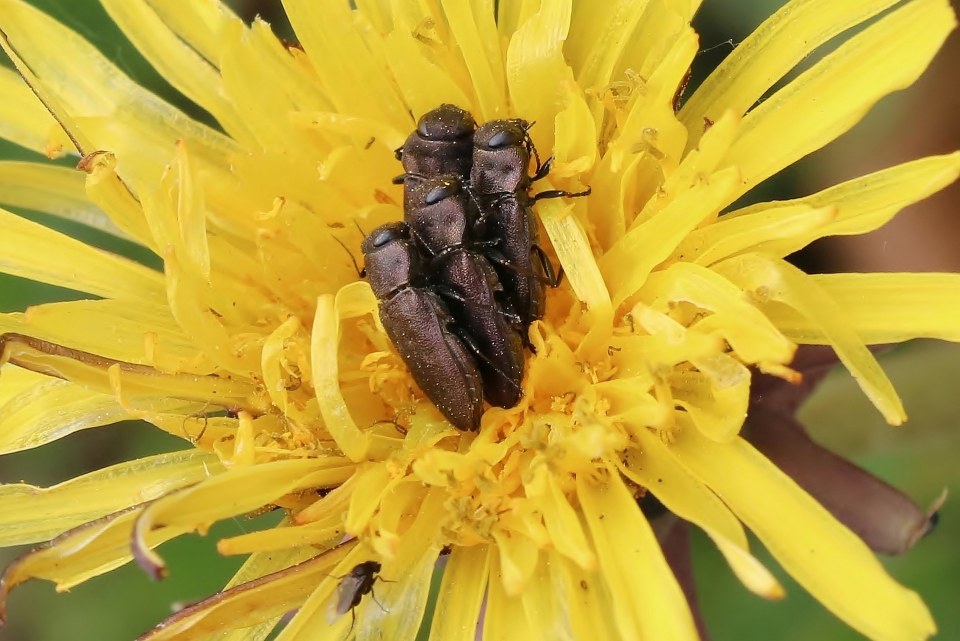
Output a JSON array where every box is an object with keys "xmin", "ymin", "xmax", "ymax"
[{"xmin": 0, "ymin": 0, "xmax": 960, "ymax": 641}]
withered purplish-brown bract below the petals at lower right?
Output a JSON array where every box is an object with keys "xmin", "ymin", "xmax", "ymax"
[{"xmin": 744, "ymin": 406, "xmax": 942, "ymax": 554}]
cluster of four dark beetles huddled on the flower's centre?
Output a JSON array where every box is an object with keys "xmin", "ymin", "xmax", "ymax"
[{"xmin": 362, "ymin": 105, "xmax": 588, "ymax": 430}]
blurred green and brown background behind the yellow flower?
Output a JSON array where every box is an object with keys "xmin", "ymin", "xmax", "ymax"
[{"xmin": 0, "ymin": 0, "xmax": 960, "ymax": 641}]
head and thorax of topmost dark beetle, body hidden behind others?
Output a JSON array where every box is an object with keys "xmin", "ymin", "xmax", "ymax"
[{"xmin": 397, "ymin": 104, "xmax": 477, "ymax": 186}]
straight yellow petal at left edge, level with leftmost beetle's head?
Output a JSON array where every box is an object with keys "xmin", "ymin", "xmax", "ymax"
[{"xmin": 0, "ymin": 209, "xmax": 164, "ymax": 304}]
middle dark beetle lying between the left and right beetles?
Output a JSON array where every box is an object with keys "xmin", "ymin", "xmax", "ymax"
[{"xmin": 404, "ymin": 175, "xmax": 524, "ymax": 407}]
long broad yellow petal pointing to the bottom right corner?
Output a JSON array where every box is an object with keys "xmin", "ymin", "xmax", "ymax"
[{"xmin": 669, "ymin": 425, "xmax": 936, "ymax": 641}]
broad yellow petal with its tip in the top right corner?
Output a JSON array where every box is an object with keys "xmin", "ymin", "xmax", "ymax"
[{"xmin": 724, "ymin": 0, "xmax": 956, "ymax": 195}]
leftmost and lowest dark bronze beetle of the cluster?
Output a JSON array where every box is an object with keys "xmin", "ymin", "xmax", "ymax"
[{"xmin": 361, "ymin": 222, "xmax": 483, "ymax": 430}]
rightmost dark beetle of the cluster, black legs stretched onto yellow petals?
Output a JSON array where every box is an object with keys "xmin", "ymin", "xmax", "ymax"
[{"xmin": 470, "ymin": 120, "xmax": 564, "ymax": 330}]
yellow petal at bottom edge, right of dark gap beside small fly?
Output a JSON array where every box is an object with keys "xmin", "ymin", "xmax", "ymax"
[{"xmin": 430, "ymin": 545, "xmax": 489, "ymax": 641}]
